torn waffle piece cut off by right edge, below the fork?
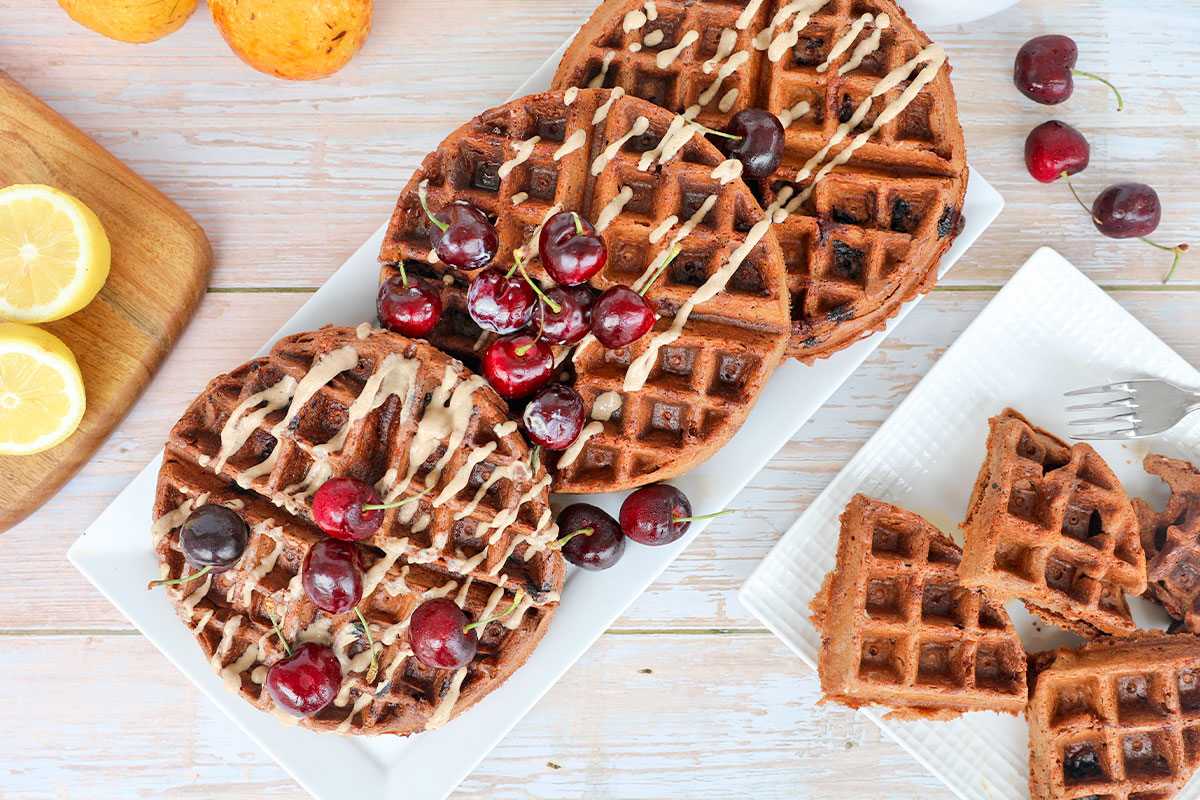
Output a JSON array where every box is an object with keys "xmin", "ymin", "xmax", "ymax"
[{"xmin": 1133, "ymin": 455, "xmax": 1200, "ymax": 633}]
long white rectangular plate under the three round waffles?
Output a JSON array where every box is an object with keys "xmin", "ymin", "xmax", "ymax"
[{"xmin": 67, "ymin": 44, "xmax": 1003, "ymax": 800}]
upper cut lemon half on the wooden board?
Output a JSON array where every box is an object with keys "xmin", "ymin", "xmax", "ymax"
[{"xmin": 0, "ymin": 184, "xmax": 112, "ymax": 323}]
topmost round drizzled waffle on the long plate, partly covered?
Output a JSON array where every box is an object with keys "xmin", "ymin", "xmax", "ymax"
[{"xmin": 553, "ymin": 0, "xmax": 967, "ymax": 363}]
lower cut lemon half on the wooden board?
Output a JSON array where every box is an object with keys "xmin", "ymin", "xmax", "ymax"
[{"xmin": 0, "ymin": 323, "xmax": 84, "ymax": 456}]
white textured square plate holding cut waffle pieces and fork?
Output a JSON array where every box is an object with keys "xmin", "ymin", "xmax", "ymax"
[{"xmin": 738, "ymin": 248, "xmax": 1200, "ymax": 800}]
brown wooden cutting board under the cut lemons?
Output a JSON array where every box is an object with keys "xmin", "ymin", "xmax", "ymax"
[{"xmin": 0, "ymin": 71, "xmax": 212, "ymax": 531}]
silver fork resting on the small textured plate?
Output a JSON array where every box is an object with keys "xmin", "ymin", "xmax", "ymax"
[{"xmin": 1063, "ymin": 379, "xmax": 1200, "ymax": 440}]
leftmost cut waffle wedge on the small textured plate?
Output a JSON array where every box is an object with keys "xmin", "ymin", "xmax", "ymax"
[{"xmin": 812, "ymin": 494, "xmax": 1026, "ymax": 717}]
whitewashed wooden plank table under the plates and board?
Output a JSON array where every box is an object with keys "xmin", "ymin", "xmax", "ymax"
[{"xmin": 0, "ymin": 0, "xmax": 1200, "ymax": 800}]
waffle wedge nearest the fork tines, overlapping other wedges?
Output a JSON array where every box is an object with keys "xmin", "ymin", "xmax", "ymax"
[{"xmin": 960, "ymin": 409, "xmax": 1146, "ymax": 637}]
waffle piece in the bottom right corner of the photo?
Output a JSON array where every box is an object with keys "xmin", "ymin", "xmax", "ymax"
[{"xmin": 1026, "ymin": 633, "xmax": 1200, "ymax": 800}]
